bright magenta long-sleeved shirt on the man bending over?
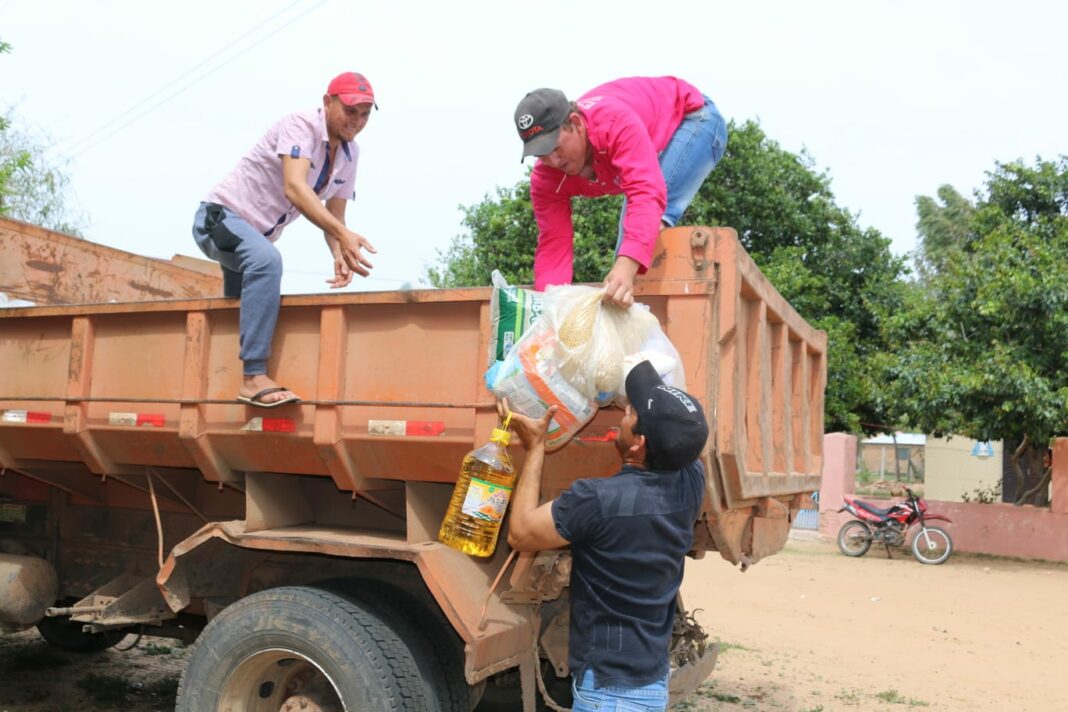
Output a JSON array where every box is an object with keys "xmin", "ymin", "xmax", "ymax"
[{"xmin": 531, "ymin": 77, "xmax": 705, "ymax": 290}]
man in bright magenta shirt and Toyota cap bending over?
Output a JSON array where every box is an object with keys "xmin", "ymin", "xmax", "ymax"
[{"xmin": 515, "ymin": 77, "xmax": 727, "ymax": 306}]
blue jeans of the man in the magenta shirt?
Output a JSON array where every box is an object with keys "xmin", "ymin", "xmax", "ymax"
[{"xmin": 615, "ymin": 96, "xmax": 727, "ymax": 254}]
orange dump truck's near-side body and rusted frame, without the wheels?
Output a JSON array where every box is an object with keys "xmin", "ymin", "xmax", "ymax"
[{"xmin": 0, "ymin": 227, "xmax": 827, "ymax": 711}]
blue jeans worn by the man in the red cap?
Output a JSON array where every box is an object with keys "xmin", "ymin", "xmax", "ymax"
[{"xmin": 193, "ymin": 203, "xmax": 282, "ymax": 376}]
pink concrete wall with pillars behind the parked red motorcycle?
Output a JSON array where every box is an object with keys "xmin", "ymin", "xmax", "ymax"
[{"xmin": 819, "ymin": 433, "xmax": 1068, "ymax": 561}]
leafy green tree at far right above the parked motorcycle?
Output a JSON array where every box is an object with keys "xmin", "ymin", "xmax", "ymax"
[{"xmin": 888, "ymin": 157, "xmax": 1068, "ymax": 502}]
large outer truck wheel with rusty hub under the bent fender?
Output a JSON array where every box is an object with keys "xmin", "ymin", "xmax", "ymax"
[{"xmin": 176, "ymin": 586, "xmax": 430, "ymax": 712}]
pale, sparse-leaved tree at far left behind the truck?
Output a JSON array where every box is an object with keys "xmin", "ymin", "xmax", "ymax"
[{"xmin": 0, "ymin": 41, "xmax": 83, "ymax": 235}]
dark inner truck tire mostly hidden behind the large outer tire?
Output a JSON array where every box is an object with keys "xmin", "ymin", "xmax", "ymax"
[{"xmin": 321, "ymin": 579, "xmax": 477, "ymax": 712}]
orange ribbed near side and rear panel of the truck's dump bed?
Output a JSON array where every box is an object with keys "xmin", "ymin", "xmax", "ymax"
[{"xmin": 0, "ymin": 228, "xmax": 827, "ymax": 542}]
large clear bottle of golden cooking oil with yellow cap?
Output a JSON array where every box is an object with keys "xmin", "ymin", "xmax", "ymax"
[{"xmin": 438, "ymin": 414, "xmax": 516, "ymax": 556}]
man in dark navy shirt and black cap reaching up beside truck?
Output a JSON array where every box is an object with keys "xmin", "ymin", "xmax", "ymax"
[{"xmin": 505, "ymin": 361, "xmax": 708, "ymax": 712}]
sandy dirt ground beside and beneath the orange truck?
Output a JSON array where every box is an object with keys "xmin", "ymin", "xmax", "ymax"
[{"xmin": 0, "ymin": 539, "xmax": 1068, "ymax": 712}]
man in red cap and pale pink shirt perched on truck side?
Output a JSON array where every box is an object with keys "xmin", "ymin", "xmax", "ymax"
[{"xmin": 193, "ymin": 72, "xmax": 377, "ymax": 408}]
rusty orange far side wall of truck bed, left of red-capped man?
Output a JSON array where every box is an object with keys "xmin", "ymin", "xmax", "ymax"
[{"xmin": 0, "ymin": 219, "xmax": 222, "ymax": 304}]
